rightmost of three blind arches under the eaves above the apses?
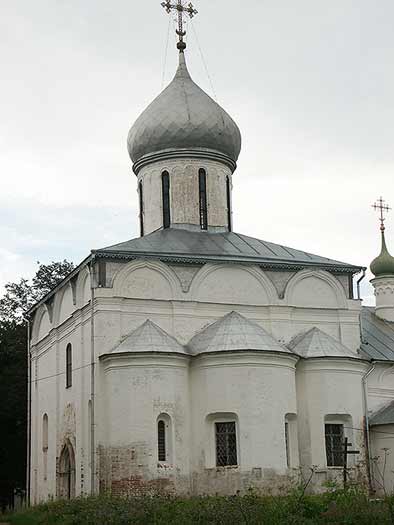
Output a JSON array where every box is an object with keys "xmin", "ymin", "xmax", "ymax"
[{"xmin": 285, "ymin": 270, "xmax": 347, "ymax": 309}]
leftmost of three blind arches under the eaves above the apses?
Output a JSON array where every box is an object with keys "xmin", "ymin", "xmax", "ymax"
[{"xmin": 114, "ymin": 260, "xmax": 182, "ymax": 301}]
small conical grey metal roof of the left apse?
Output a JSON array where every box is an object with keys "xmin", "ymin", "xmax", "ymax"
[{"xmin": 105, "ymin": 319, "xmax": 186, "ymax": 354}]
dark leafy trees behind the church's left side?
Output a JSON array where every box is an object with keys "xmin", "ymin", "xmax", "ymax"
[{"xmin": 0, "ymin": 260, "xmax": 74, "ymax": 509}]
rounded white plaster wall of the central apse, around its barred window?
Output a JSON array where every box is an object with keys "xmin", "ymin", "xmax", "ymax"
[{"xmin": 191, "ymin": 352, "xmax": 298, "ymax": 494}]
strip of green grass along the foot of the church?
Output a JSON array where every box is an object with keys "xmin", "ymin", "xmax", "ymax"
[{"xmin": 0, "ymin": 491, "xmax": 394, "ymax": 525}]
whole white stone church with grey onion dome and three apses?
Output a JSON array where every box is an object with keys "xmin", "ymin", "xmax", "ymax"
[{"xmin": 29, "ymin": 14, "xmax": 394, "ymax": 503}]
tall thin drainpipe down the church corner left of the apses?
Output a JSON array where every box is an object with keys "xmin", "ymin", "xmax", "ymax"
[{"xmin": 88, "ymin": 255, "xmax": 96, "ymax": 496}]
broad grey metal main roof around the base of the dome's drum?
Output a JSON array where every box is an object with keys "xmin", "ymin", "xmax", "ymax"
[{"xmin": 93, "ymin": 228, "xmax": 361, "ymax": 273}]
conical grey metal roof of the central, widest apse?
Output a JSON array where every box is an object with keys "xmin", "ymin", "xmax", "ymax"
[{"xmin": 187, "ymin": 312, "xmax": 292, "ymax": 355}]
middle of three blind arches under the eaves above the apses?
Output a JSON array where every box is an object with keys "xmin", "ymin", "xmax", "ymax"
[{"xmin": 190, "ymin": 264, "xmax": 278, "ymax": 306}]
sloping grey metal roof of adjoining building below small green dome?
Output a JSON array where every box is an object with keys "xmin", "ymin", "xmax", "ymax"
[{"xmin": 361, "ymin": 307, "xmax": 394, "ymax": 361}]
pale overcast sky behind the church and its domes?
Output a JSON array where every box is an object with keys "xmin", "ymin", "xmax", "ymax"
[{"xmin": 0, "ymin": 0, "xmax": 394, "ymax": 302}]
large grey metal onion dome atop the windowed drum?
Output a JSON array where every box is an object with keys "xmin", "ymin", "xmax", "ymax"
[{"xmin": 127, "ymin": 52, "xmax": 241, "ymax": 173}]
